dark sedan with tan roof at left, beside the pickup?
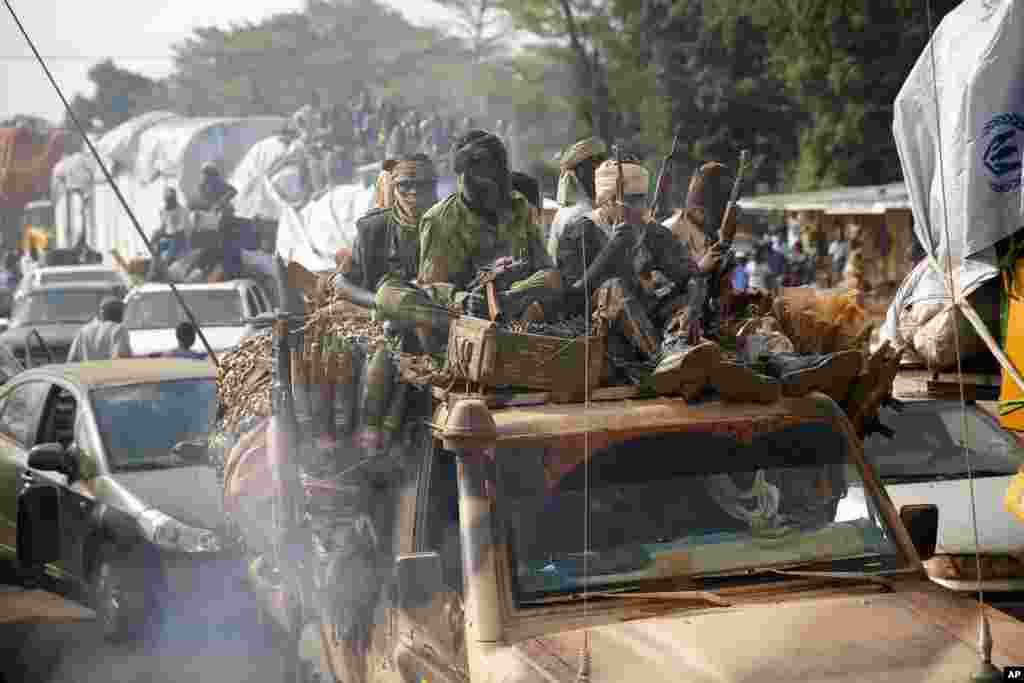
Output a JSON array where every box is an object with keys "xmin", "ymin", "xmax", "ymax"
[{"xmin": 0, "ymin": 358, "xmax": 245, "ymax": 639}]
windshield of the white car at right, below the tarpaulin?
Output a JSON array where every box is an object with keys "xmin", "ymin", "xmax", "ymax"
[{"xmin": 864, "ymin": 400, "xmax": 1024, "ymax": 483}]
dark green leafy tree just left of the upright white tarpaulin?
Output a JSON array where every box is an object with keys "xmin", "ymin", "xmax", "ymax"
[{"xmin": 729, "ymin": 0, "xmax": 956, "ymax": 189}]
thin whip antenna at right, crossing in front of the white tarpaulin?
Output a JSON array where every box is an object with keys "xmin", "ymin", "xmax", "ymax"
[{"xmin": 925, "ymin": 0, "xmax": 1001, "ymax": 683}]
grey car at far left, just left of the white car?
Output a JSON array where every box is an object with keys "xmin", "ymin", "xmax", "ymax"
[{"xmin": 0, "ymin": 283, "xmax": 130, "ymax": 366}]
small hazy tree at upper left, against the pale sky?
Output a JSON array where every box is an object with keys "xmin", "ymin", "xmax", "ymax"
[{"xmin": 63, "ymin": 59, "xmax": 168, "ymax": 129}]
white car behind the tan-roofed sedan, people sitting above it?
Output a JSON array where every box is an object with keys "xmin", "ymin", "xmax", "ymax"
[{"xmin": 125, "ymin": 280, "xmax": 270, "ymax": 356}]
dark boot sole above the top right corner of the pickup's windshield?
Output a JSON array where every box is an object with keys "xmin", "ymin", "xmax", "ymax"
[{"xmin": 765, "ymin": 351, "xmax": 864, "ymax": 402}]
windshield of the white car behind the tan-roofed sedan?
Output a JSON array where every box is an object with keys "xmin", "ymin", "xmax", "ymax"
[{"xmin": 125, "ymin": 290, "xmax": 245, "ymax": 330}]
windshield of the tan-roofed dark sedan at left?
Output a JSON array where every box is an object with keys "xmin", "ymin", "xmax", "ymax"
[{"xmin": 91, "ymin": 379, "xmax": 217, "ymax": 470}]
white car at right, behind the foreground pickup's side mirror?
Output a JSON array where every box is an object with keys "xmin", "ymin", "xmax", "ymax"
[{"xmin": 864, "ymin": 399, "xmax": 1024, "ymax": 591}]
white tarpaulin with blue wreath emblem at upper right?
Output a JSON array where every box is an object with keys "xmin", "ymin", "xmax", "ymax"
[{"xmin": 881, "ymin": 0, "xmax": 1024, "ymax": 385}]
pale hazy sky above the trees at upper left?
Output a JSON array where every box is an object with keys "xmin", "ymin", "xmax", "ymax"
[{"xmin": 0, "ymin": 0, "xmax": 456, "ymax": 122}]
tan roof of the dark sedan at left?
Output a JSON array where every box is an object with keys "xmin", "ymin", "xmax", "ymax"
[{"xmin": 17, "ymin": 358, "xmax": 217, "ymax": 390}]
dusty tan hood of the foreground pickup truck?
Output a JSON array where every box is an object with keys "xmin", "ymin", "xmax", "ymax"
[{"xmin": 505, "ymin": 587, "xmax": 1024, "ymax": 683}]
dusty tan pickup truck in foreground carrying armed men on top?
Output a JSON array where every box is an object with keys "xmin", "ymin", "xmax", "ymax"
[{"xmin": 241, "ymin": 393, "xmax": 1024, "ymax": 683}]
